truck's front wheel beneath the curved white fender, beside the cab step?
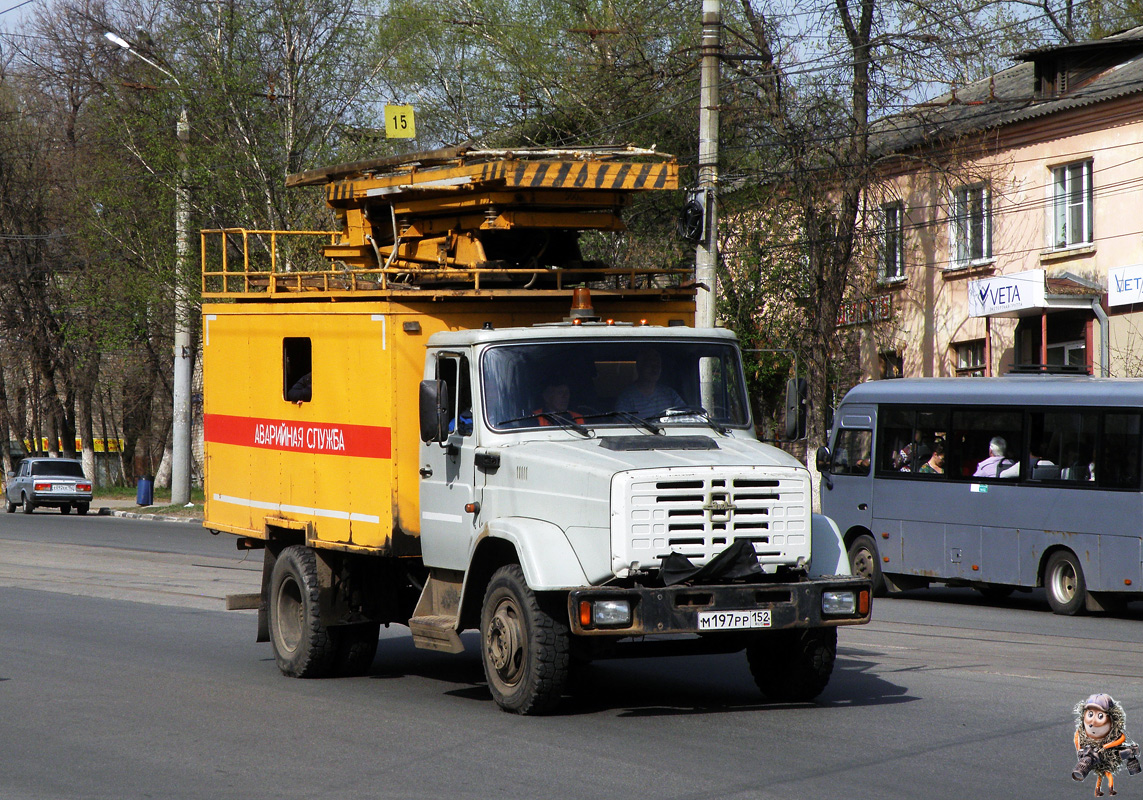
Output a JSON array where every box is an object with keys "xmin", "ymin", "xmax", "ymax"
[{"xmin": 480, "ymin": 563, "xmax": 569, "ymax": 714}]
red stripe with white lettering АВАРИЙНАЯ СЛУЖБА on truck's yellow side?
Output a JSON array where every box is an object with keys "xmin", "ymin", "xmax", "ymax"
[{"xmin": 203, "ymin": 414, "xmax": 392, "ymax": 458}]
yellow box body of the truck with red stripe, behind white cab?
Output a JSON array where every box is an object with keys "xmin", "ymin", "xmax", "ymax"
[{"xmin": 202, "ymin": 293, "xmax": 694, "ymax": 555}]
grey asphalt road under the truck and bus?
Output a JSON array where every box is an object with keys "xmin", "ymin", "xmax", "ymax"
[{"xmin": 0, "ymin": 514, "xmax": 1143, "ymax": 800}]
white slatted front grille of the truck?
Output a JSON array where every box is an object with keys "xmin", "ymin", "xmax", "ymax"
[{"xmin": 612, "ymin": 467, "xmax": 809, "ymax": 570}]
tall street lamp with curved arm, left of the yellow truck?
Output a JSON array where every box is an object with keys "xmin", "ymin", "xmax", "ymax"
[{"xmin": 103, "ymin": 31, "xmax": 191, "ymax": 505}]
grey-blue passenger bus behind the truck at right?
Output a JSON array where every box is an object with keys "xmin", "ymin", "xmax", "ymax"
[{"xmin": 817, "ymin": 375, "xmax": 1143, "ymax": 615}]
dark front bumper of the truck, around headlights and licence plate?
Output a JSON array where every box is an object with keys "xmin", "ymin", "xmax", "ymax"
[{"xmin": 568, "ymin": 577, "xmax": 873, "ymax": 637}]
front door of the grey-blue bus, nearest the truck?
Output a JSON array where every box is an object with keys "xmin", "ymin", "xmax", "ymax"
[{"xmin": 822, "ymin": 406, "xmax": 877, "ymax": 533}]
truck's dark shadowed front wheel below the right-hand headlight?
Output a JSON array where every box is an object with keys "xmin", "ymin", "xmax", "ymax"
[{"xmin": 746, "ymin": 627, "xmax": 838, "ymax": 703}]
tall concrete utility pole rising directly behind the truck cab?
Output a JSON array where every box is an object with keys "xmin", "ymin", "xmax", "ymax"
[{"xmin": 695, "ymin": 0, "xmax": 722, "ymax": 328}]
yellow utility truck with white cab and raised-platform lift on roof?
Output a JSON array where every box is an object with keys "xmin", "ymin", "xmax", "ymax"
[{"xmin": 202, "ymin": 149, "xmax": 870, "ymax": 713}]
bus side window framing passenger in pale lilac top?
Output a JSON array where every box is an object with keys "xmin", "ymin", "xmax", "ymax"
[{"xmin": 945, "ymin": 408, "xmax": 1024, "ymax": 480}]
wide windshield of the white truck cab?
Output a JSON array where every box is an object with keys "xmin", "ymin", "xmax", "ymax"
[{"xmin": 480, "ymin": 339, "xmax": 750, "ymax": 430}]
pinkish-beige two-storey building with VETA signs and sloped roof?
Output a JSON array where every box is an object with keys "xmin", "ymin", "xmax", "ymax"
[{"xmin": 839, "ymin": 27, "xmax": 1143, "ymax": 378}]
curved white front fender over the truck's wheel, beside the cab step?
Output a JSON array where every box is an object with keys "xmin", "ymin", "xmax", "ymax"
[{"xmin": 473, "ymin": 517, "xmax": 590, "ymax": 592}]
